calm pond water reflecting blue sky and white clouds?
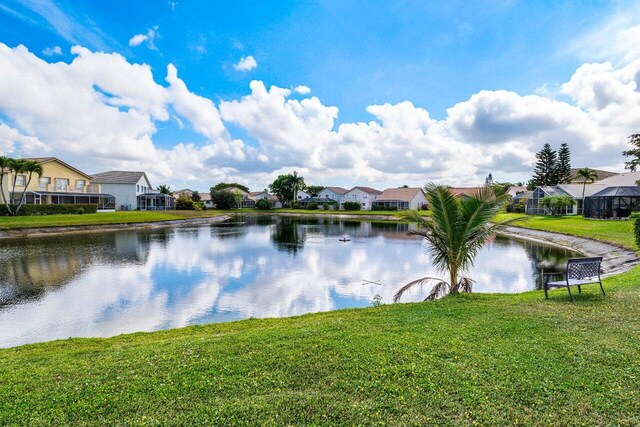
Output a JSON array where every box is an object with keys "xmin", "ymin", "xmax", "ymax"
[{"xmin": 0, "ymin": 216, "xmax": 575, "ymax": 347}]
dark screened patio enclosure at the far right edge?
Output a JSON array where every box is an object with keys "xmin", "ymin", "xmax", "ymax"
[{"xmin": 584, "ymin": 186, "xmax": 640, "ymax": 219}]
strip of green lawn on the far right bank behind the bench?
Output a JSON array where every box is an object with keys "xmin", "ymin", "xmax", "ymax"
[{"xmin": 497, "ymin": 214, "xmax": 638, "ymax": 250}]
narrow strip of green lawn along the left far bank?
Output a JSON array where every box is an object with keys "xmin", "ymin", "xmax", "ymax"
[{"xmin": 0, "ymin": 211, "xmax": 228, "ymax": 230}]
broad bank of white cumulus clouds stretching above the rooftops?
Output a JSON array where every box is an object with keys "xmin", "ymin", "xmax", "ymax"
[{"xmin": 0, "ymin": 39, "xmax": 640, "ymax": 188}]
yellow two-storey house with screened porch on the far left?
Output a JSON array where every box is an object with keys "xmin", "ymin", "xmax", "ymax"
[{"xmin": 3, "ymin": 157, "xmax": 115, "ymax": 211}]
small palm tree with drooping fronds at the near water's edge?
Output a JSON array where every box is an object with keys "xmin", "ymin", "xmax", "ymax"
[{"xmin": 394, "ymin": 184, "xmax": 521, "ymax": 302}]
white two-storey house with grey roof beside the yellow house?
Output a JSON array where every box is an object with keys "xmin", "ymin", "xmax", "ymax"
[{"xmin": 91, "ymin": 171, "xmax": 153, "ymax": 211}]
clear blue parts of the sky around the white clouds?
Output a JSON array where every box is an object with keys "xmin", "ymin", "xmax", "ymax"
[{"xmin": 0, "ymin": 0, "xmax": 637, "ymax": 189}]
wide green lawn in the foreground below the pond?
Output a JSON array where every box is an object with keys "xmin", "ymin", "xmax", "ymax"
[{"xmin": 0, "ymin": 268, "xmax": 640, "ymax": 426}]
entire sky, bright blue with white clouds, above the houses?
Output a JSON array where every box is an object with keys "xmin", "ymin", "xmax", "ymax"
[{"xmin": 0, "ymin": 0, "xmax": 640, "ymax": 191}]
